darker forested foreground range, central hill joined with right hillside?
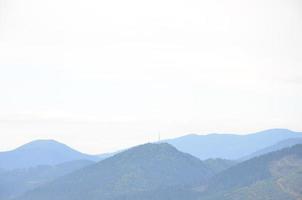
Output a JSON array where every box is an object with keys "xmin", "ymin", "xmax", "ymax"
[{"xmin": 17, "ymin": 144, "xmax": 302, "ymax": 200}]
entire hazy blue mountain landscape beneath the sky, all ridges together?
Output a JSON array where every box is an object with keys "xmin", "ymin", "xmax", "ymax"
[{"xmin": 0, "ymin": 129, "xmax": 302, "ymax": 200}]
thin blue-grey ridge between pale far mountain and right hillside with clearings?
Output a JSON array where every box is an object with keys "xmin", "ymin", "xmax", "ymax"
[{"xmin": 240, "ymin": 138, "xmax": 302, "ymax": 161}]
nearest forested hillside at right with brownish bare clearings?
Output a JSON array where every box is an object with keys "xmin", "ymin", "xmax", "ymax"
[{"xmin": 197, "ymin": 145, "xmax": 302, "ymax": 200}]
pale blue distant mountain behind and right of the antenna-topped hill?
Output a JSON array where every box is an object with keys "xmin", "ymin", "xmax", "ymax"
[{"xmin": 165, "ymin": 129, "xmax": 302, "ymax": 160}]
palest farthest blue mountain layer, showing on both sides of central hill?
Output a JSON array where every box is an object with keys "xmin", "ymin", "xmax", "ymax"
[{"xmin": 0, "ymin": 129, "xmax": 302, "ymax": 170}]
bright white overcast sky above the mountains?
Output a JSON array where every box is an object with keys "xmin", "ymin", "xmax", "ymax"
[{"xmin": 0, "ymin": 0, "xmax": 302, "ymax": 153}]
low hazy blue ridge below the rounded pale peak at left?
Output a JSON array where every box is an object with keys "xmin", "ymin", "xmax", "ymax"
[{"xmin": 0, "ymin": 160, "xmax": 95, "ymax": 200}]
